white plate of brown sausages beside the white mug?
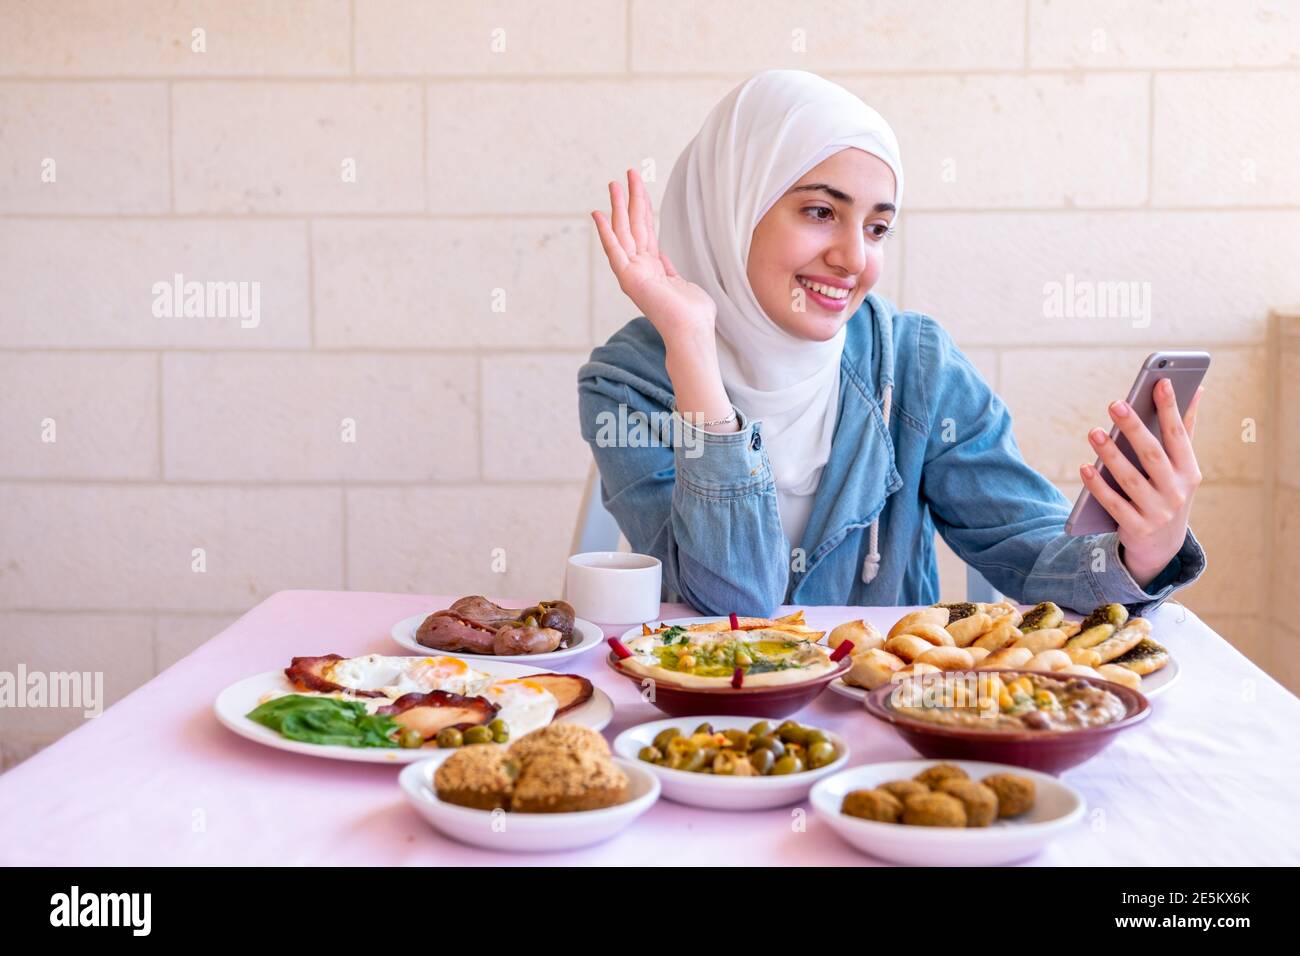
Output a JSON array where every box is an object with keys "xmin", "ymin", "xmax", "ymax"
[{"xmin": 391, "ymin": 594, "xmax": 605, "ymax": 665}]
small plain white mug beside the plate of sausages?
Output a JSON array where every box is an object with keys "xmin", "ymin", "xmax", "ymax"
[{"xmin": 564, "ymin": 551, "xmax": 663, "ymax": 624}]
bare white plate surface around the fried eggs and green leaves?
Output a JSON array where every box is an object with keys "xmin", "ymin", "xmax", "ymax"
[{"xmin": 213, "ymin": 659, "xmax": 614, "ymax": 763}]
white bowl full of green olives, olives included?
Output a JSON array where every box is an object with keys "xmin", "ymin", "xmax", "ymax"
[{"xmin": 614, "ymin": 715, "xmax": 849, "ymax": 810}]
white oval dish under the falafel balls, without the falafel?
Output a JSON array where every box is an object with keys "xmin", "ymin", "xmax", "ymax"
[{"xmin": 811, "ymin": 760, "xmax": 1088, "ymax": 866}]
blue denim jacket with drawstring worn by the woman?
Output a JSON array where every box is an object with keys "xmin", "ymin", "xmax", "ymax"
[{"xmin": 579, "ymin": 294, "xmax": 1205, "ymax": 615}]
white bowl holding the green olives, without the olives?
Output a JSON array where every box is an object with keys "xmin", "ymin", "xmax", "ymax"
[{"xmin": 614, "ymin": 717, "xmax": 849, "ymax": 810}]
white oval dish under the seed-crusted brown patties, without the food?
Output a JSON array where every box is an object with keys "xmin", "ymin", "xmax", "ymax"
[{"xmin": 398, "ymin": 757, "xmax": 659, "ymax": 852}]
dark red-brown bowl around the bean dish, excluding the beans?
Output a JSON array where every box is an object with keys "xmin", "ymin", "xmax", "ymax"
[{"xmin": 866, "ymin": 670, "xmax": 1151, "ymax": 774}]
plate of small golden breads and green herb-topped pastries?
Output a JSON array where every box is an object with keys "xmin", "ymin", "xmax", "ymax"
[{"xmin": 827, "ymin": 601, "xmax": 1178, "ymax": 700}]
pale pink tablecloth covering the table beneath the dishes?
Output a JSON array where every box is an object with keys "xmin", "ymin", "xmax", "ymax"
[{"xmin": 0, "ymin": 591, "xmax": 1300, "ymax": 865}]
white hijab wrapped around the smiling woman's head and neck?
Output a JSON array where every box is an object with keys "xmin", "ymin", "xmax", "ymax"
[{"xmin": 659, "ymin": 70, "xmax": 902, "ymax": 546}]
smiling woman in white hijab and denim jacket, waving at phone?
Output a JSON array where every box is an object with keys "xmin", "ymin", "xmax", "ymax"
[{"xmin": 579, "ymin": 70, "xmax": 1205, "ymax": 615}]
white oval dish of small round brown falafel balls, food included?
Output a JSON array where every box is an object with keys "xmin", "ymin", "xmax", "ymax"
[{"xmin": 810, "ymin": 760, "xmax": 1088, "ymax": 866}]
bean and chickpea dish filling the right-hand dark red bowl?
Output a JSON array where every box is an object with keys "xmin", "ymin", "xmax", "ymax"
[{"xmin": 889, "ymin": 671, "xmax": 1127, "ymax": 734}]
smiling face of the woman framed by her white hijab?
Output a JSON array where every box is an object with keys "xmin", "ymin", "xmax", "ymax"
[{"xmin": 745, "ymin": 148, "xmax": 894, "ymax": 342}]
